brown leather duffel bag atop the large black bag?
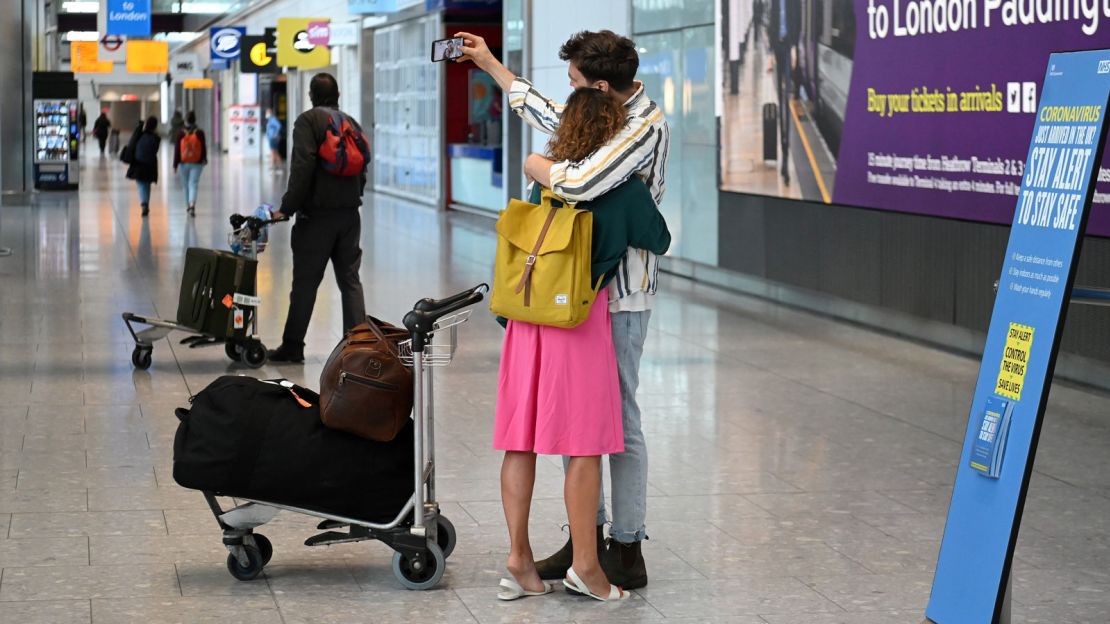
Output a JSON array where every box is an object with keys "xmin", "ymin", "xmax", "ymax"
[{"xmin": 320, "ymin": 316, "xmax": 413, "ymax": 442}]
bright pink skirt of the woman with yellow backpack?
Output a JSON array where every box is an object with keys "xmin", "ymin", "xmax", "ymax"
[{"xmin": 493, "ymin": 291, "xmax": 624, "ymax": 456}]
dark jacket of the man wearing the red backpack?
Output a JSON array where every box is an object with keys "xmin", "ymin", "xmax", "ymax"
[{"xmin": 281, "ymin": 107, "xmax": 366, "ymax": 215}]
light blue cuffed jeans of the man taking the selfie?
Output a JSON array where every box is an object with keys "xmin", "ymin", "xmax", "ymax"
[{"xmin": 563, "ymin": 306, "xmax": 652, "ymax": 544}]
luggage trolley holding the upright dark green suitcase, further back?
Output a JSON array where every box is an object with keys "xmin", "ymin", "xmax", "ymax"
[{"xmin": 123, "ymin": 205, "xmax": 289, "ymax": 370}]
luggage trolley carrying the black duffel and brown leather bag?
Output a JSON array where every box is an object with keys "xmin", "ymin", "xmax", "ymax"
[{"xmin": 203, "ymin": 284, "xmax": 490, "ymax": 590}]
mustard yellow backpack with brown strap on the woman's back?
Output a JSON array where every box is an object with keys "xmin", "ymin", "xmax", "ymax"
[{"xmin": 490, "ymin": 189, "xmax": 601, "ymax": 328}]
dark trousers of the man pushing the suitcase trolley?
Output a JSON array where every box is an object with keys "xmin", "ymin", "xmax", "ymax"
[{"xmin": 282, "ymin": 210, "xmax": 366, "ymax": 348}]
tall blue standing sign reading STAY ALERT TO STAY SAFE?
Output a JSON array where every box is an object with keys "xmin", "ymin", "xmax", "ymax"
[{"xmin": 926, "ymin": 50, "xmax": 1110, "ymax": 624}]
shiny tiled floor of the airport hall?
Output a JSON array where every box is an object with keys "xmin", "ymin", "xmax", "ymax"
[{"xmin": 0, "ymin": 146, "xmax": 1110, "ymax": 624}]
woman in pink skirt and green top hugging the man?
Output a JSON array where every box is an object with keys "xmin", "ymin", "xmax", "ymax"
[{"xmin": 494, "ymin": 84, "xmax": 670, "ymax": 601}]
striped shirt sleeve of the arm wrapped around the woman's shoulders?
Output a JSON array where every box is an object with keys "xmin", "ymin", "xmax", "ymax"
[{"xmin": 551, "ymin": 110, "xmax": 666, "ymax": 201}]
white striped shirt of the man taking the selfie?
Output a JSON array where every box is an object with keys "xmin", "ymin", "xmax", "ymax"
[{"xmin": 508, "ymin": 78, "xmax": 670, "ymax": 312}]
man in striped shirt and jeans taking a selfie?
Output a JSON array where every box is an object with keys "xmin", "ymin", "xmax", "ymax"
[{"xmin": 456, "ymin": 30, "xmax": 670, "ymax": 590}]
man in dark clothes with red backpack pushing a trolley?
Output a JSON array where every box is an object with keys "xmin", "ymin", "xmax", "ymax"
[{"xmin": 270, "ymin": 73, "xmax": 370, "ymax": 362}]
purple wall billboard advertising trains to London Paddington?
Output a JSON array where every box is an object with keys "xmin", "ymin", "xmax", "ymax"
[{"xmin": 719, "ymin": 0, "xmax": 1110, "ymax": 236}]
